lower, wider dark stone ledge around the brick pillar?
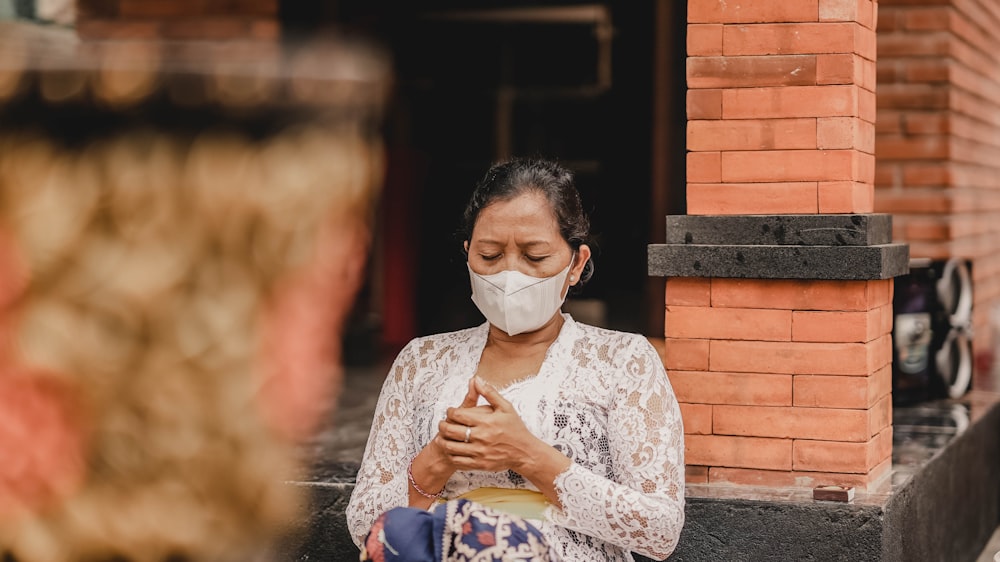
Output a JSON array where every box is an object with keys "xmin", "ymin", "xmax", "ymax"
[{"xmin": 648, "ymin": 244, "xmax": 910, "ymax": 280}]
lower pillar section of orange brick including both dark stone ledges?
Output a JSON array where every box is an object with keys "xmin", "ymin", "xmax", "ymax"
[{"xmin": 650, "ymin": 215, "xmax": 909, "ymax": 489}]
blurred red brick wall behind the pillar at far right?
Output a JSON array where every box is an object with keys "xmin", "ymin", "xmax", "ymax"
[{"xmin": 875, "ymin": 0, "xmax": 1000, "ymax": 355}]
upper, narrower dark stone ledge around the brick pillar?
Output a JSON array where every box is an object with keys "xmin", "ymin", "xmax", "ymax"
[{"xmin": 666, "ymin": 214, "xmax": 892, "ymax": 246}]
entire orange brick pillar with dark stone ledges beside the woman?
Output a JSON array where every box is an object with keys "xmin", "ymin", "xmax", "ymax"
[{"xmin": 650, "ymin": 0, "xmax": 908, "ymax": 489}]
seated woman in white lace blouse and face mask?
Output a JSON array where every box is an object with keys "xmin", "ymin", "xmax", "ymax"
[{"xmin": 347, "ymin": 155, "xmax": 684, "ymax": 561}]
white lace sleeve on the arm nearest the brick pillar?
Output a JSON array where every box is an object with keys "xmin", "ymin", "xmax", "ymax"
[{"xmin": 547, "ymin": 337, "xmax": 684, "ymax": 560}]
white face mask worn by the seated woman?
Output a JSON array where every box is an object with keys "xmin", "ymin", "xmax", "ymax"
[{"xmin": 469, "ymin": 261, "xmax": 573, "ymax": 336}]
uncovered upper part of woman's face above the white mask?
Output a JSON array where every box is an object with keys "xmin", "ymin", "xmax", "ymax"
[{"xmin": 466, "ymin": 191, "xmax": 590, "ymax": 285}]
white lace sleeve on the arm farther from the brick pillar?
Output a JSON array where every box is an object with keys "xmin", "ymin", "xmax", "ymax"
[{"xmin": 346, "ymin": 340, "xmax": 417, "ymax": 546}]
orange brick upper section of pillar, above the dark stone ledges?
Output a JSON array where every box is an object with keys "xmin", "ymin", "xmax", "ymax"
[{"xmin": 687, "ymin": 0, "xmax": 876, "ymax": 215}]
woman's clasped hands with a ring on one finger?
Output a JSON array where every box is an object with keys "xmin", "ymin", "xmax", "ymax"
[{"xmin": 436, "ymin": 377, "xmax": 537, "ymax": 472}]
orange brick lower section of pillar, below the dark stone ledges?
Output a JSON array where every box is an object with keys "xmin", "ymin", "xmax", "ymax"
[{"xmin": 665, "ymin": 278, "xmax": 892, "ymax": 488}]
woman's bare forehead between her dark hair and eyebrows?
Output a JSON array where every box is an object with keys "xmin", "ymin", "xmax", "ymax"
[{"xmin": 472, "ymin": 190, "xmax": 559, "ymax": 239}]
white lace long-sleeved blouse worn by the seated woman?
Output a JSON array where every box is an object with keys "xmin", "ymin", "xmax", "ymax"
[{"xmin": 347, "ymin": 314, "xmax": 684, "ymax": 562}]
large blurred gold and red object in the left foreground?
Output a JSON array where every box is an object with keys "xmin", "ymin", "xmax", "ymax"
[{"xmin": 0, "ymin": 22, "xmax": 389, "ymax": 562}]
